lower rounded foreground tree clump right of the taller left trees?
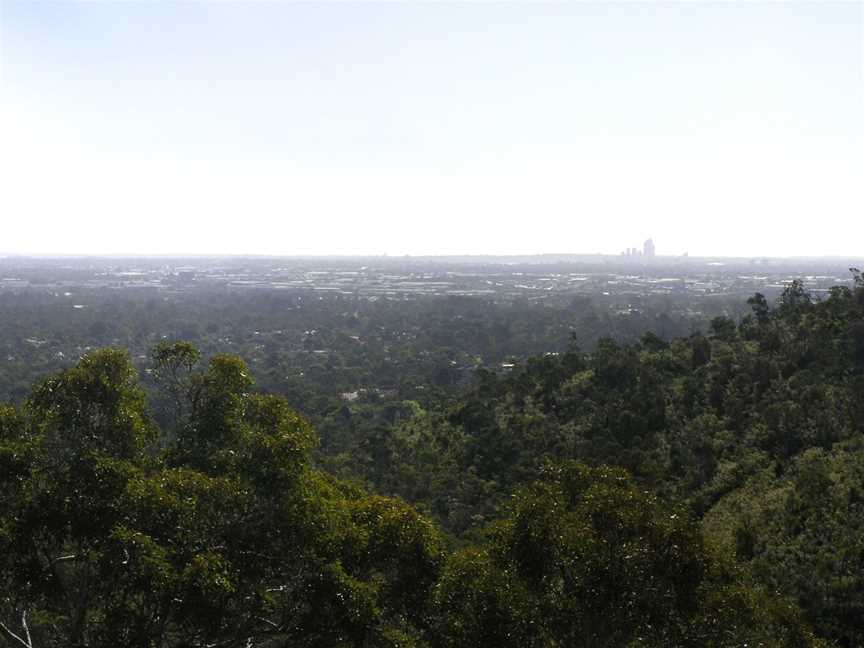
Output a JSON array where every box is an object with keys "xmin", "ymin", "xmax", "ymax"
[{"xmin": 436, "ymin": 464, "xmax": 818, "ymax": 647}]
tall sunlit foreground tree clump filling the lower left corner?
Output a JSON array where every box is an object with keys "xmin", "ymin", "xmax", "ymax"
[{"xmin": 0, "ymin": 350, "xmax": 442, "ymax": 647}]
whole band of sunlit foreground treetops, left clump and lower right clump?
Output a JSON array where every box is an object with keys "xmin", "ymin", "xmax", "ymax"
[{"xmin": 0, "ymin": 345, "xmax": 815, "ymax": 647}]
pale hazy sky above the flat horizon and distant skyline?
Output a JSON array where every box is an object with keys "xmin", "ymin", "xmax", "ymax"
[{"xmin": 0, "ymin": 0, "xmax": 864, "ymax": 256}]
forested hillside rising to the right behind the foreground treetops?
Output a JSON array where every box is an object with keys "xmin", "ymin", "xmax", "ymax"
[{"xmin": 340, "ymin": 275, "xmax": 864, "ymax": 646}]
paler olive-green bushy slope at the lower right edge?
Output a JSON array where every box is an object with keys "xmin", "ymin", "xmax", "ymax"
[{"xmin": 706, "ymin": 441, "xmax": 864, "ymax": 646}]
